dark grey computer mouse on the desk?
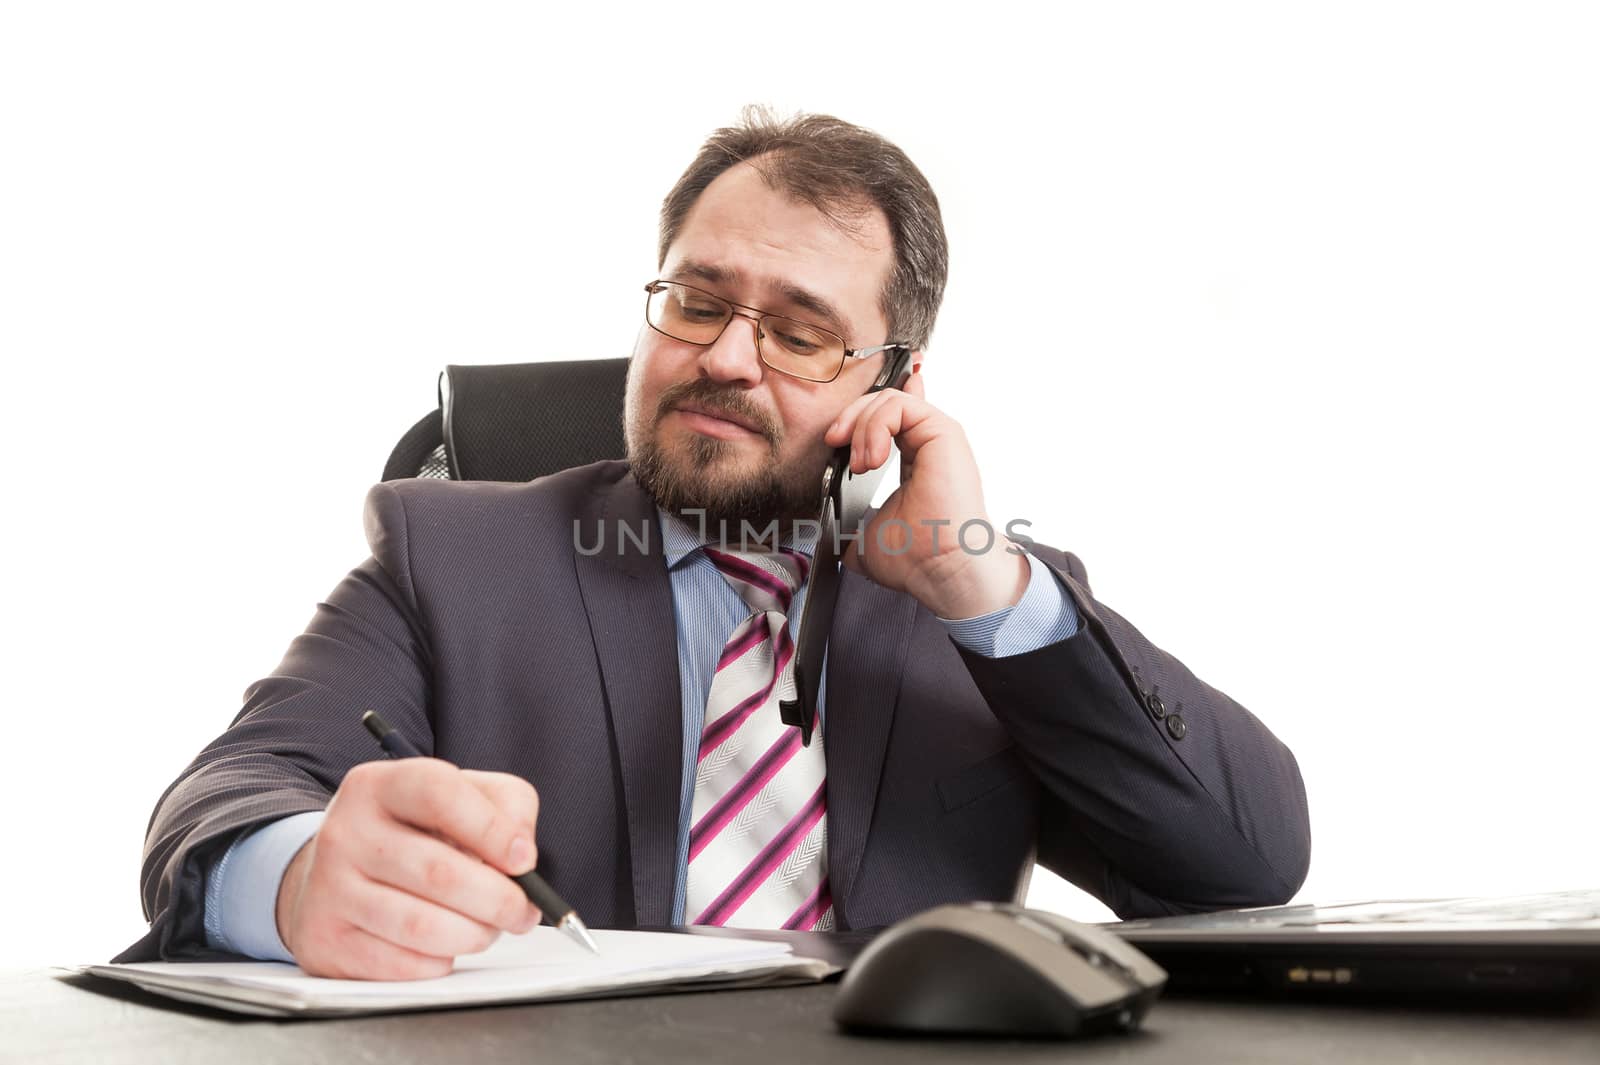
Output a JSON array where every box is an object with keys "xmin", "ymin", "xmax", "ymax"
[{"xmin": 834, "ymin": 902, "xmax": 1166, "ymax": 1036}]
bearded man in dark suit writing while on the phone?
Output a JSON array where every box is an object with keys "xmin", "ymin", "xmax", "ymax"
[{"xmin": 123, "ymin": 112, "xmax": 1309, "ymax": 979}]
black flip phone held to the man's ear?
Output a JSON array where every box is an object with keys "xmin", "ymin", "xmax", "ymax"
[{"xmin": 778, "ymin": 345, "xmax": 912, "ymax": 747}]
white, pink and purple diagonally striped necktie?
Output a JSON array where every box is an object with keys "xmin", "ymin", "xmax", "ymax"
[{"xmin": 685, "ymin": 547, "xmax": 834, "ymax": 931}]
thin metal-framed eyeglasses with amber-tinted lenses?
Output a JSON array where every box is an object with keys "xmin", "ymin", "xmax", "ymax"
[{"xmin": 645, "ymin": 281, "xmax": 906, "ymax": 382}]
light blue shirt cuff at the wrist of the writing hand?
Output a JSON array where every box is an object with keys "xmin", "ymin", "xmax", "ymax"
[{"xmin": 205, "ymin": 809, "xmax": 326, "ymax": 961}]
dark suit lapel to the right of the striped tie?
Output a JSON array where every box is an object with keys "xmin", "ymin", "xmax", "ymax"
[{"xmin": 822, "ymin": 571, "xmax": 917, "ymax": 916}]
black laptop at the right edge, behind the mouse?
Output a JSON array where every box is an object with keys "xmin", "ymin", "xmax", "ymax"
[{"xmin": 1107, "ymin": 891, "xmax": 1600, "ymax": 996}]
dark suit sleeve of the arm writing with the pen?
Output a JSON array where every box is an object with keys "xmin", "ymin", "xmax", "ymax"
[{"xmin": 115, "ymin": 485, "xmax": 432, "ymax": 961}]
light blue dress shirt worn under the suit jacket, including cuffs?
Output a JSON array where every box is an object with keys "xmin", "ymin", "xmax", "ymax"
[{"xmin": 205, "ymin": 509, "xmax": 1078, "ymax": 961}]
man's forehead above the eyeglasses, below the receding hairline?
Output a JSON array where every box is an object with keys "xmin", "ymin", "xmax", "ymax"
[{"xmin": 662, "ymin": 163, "xmax": 893, "ymax": 345}]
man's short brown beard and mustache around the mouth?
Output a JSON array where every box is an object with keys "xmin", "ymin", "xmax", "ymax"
[{"xmin": 626, "ymin": 375, "xmax": 824, "ymax": 536}]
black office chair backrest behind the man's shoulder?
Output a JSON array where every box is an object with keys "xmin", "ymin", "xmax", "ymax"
[{"xmin": 384, "ymin": 358, "xmax": 629, "ymax": 481}]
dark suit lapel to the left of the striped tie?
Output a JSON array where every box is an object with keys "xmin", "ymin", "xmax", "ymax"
[{"xmin": 574, "ymin": 473, "xmax": 683, "ymax": 924}]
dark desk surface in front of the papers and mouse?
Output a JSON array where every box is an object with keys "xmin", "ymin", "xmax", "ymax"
[{"xmin": 0, "ymin": 969, "xmax": 1600, "ymax": 1065}]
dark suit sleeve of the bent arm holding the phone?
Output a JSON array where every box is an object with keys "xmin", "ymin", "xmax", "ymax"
[{"xmin": 957, "ymin": 544, "xmax": 1310, "ymax": 919}]
